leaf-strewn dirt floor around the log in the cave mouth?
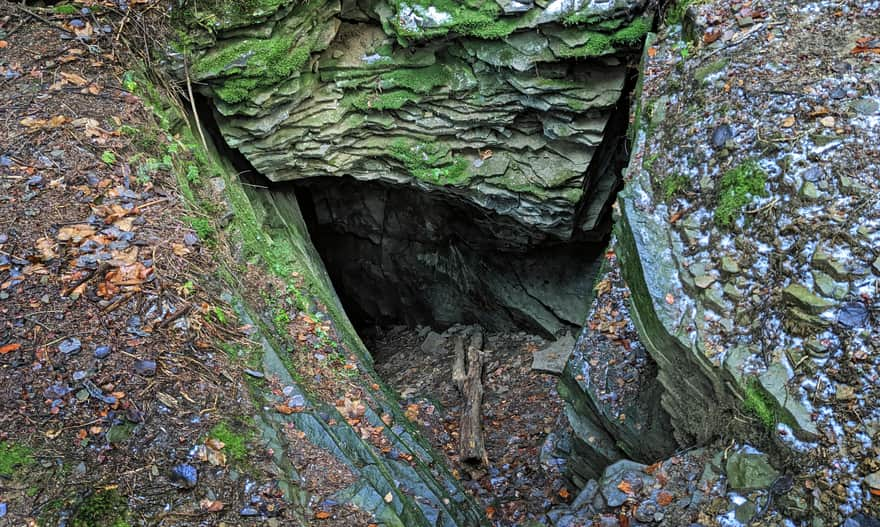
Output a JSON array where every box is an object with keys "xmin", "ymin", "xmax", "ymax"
[{"xmin": 367, "ymin": 326, "xmax": 575, "ymax": 526}]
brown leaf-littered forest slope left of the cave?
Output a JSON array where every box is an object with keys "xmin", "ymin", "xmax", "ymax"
[{"xmin": 0, "ymin": 1, "xmax": 330, "ymax": 527}]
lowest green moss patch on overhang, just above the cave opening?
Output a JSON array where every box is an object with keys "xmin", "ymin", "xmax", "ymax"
[{"xmin": 389, "ymin": 139, "xmax": 469, "ymax": 185}]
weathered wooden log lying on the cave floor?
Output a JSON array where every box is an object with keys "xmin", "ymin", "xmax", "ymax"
[{"xmin": 453, "ymin": 329, "xmax": 489, "ymax": 465}]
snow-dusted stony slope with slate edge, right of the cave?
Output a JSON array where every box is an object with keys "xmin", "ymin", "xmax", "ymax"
[{"xmin": 617, "ymin": 1, "xmax": 880, "ymax": 525}]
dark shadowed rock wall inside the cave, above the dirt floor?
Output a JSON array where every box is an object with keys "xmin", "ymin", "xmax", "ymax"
[{"xmin": 295, "ymin": 178, "xmax": 604, "ymax": 335}]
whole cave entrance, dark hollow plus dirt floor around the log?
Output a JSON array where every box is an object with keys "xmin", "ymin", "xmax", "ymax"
[{"xmin": 288, "ymin": 177, "xmax": 608, "ymax": 525}]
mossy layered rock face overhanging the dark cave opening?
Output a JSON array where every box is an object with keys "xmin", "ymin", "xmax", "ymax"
[{"xmin": 186, "ymin": 0, "xmax": 649, "ymax": 239}]
